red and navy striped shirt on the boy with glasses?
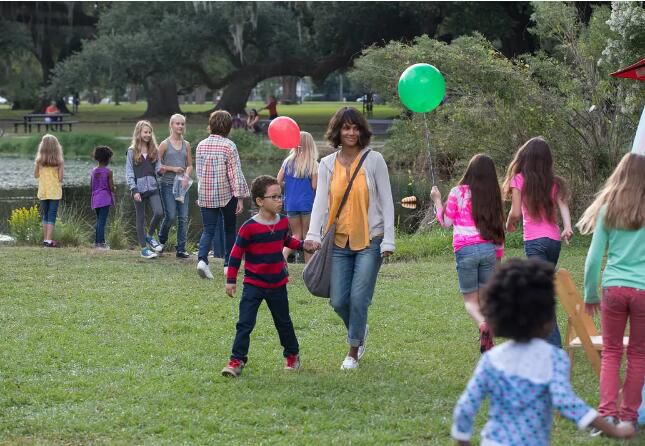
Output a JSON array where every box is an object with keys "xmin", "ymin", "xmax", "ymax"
[{"xmin": 226, "ymin": 216, "xmax": 303, "ymax": 288}]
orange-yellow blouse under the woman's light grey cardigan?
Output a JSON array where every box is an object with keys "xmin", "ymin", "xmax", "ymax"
[{"xmin": 327, "ymin": 156, "xmax": 370, "ymax": 251}]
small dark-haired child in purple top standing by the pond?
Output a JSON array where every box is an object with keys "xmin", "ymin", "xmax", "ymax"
[{"xmin": 90, "ymin": 146, "xmax": 116, "ymax": 249}]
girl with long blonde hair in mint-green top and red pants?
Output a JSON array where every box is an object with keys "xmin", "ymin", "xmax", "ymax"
[{"xmin": 576, "ymin": 153, "xmax": 645, "ymax": 432}]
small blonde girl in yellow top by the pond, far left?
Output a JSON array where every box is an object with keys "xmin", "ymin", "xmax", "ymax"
[{"xmin": 34, "ymin": 134, "xmax": 63, "ymax": 248}]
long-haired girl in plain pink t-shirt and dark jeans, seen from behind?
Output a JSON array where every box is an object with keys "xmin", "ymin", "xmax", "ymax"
[{"xmin": 503, "ymin": 136, "xmax": 573, "ymax": 347}]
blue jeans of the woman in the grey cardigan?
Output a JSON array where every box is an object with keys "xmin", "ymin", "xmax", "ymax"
[{"xmin": 329, "ymin": 237, "xmax": 383, "ymax": 347}]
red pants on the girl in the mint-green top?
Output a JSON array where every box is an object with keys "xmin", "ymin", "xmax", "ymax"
[{"xmin": 598, "ymin": 286, "xmax": 645, "ymax": 421}]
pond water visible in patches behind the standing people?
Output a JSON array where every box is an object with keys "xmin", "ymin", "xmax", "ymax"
[{"xmin": 0, "ymin": 156, "xmax": 429, "ymax": 242}]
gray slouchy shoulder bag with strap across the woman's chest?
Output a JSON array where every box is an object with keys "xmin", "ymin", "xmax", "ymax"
[{"xmin": 302, "ymin": 149, "xmax": 371, "ymax": 298}]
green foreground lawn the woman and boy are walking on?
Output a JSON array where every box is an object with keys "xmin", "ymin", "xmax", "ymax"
[{"xmin": 0, "ymin": 247, "xmax": 616, "ymax": 445}]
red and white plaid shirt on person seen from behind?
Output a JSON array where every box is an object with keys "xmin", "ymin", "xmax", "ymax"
[{"xmin": 196, "ymin": 135, "xmax": 250, "ymax": 208}]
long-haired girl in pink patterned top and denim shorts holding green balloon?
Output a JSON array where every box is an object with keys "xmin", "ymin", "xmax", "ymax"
[{"xmin": 430, "ymin": 154, "xmax": 504, "ymax": 353}]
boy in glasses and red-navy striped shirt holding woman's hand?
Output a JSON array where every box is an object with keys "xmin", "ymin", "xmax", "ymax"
[{"xmin": 222, "ymin": 175, "xmax": 303, "ymax": 377}]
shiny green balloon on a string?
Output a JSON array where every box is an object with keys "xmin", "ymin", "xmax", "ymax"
[{"xmin": 399, "ymin": 63, "xmax": 446, "ymax": 113}]
